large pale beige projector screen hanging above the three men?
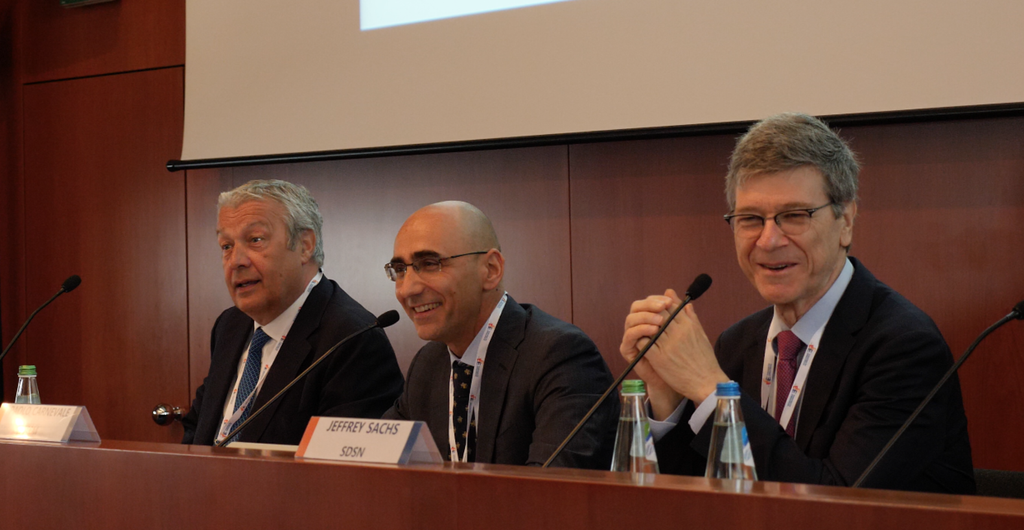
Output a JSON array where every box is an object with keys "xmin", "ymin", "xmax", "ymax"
[{"xmin": 181, "ymin": 0, "xmax": 1024, "ymax": 161}]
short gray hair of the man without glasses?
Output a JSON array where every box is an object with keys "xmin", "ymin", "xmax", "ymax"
[{"xmin": 217, "ymin": 180, "xmax": 324, "ymax": 266}]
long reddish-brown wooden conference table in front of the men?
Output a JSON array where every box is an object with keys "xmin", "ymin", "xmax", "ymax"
[{"xmin": 0, "ymin": 441, "xmax": 1024, "ymax": 530}]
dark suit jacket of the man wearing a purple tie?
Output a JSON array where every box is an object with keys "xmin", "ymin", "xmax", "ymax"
[{"xmin": 657, "ymin": 258, "xmax": 975, "ymax": 493}]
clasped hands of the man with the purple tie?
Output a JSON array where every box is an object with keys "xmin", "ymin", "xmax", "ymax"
[{"xmin": 618, "ymin": 289, "xmax": 729, "ymax": 419}]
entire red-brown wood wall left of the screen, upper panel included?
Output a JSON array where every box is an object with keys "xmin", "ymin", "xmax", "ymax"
[{"xmin": 0, "ymin": 0, "xmax": 188, "ymax": 441}]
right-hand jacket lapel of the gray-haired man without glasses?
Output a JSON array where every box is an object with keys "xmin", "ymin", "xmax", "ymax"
[{"xmin": 236, "ymin": 276, "xmax": 334, "ymax": 442}]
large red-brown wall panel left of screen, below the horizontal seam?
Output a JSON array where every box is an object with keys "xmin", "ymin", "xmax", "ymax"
[{"xmin": 23, "ymin": 68, "xmax": 188, "ymax": 441}]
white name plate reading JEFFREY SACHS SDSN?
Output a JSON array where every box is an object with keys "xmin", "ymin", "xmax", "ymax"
[{"xmin": 295, "ymin": 416, "xmax": 443, "ymax": 463}]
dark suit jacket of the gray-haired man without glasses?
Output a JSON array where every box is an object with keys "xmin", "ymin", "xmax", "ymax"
[{"xmin": 182, "ymin": 276, "xmax": 402, "ymax": 445}]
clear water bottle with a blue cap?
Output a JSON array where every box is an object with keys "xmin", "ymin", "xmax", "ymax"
[{"xmin": 705, "ymin": 381, "xmax": 758, "ymax": 480}]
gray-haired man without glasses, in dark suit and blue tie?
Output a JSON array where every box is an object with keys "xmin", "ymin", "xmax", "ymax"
[{"xmin": 182, "ymin": 180, "xmax": 402, "ymax": 445}]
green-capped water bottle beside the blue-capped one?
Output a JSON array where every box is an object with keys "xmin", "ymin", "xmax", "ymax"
[{"xmin": 611, "ymin": 380, "xmax": 657, "ymax": 474}]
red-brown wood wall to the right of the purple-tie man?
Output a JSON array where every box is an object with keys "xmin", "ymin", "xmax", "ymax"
[{"xmin": 849, "ymin": 118, "xmax": 1024, "ymax": 470}]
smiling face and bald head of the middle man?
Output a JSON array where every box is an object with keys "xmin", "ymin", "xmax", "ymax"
[{"xmin": 392, "ymin": 207, "xmax": 504, "ymax": 357}]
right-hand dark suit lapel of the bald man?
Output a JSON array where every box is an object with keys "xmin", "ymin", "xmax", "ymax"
[{"xmin": 473, "ymin": 297, "xmax": 526, "ymax": 462}]
